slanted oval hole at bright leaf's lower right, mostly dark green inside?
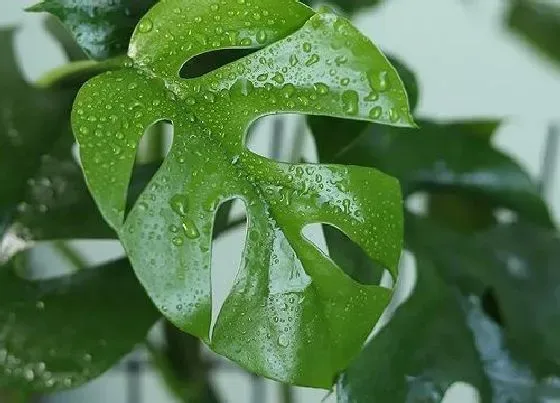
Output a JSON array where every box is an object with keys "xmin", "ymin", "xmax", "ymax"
[{"xmin": 302, "ymin": 224, "xmax": 393, "ymax": 288}]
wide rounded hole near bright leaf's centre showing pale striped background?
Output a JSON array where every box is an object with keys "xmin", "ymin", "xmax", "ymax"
[{"xmin": 245, "ymin": 114, "xmax": 317, "ymax": 163}]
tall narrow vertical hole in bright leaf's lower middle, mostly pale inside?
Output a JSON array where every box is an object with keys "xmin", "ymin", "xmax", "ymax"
[{"xmin": 210, "ymin": 199, "xmax": 247, "ymax": 329}]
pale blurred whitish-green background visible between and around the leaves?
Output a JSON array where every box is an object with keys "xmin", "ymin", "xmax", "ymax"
[{"xmin": 0, "ymin": 0, "xmax": 560, "ymax": 403}]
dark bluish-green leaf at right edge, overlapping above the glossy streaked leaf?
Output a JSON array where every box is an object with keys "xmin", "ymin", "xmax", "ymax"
[{"xmin": 406, "ymin": 219, "xmax": 560, "ymax": 377}]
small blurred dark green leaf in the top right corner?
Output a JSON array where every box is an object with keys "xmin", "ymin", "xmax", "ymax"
[{"xmin": 507, "ymin": 0, "xmax": 560, "ymax": 67}]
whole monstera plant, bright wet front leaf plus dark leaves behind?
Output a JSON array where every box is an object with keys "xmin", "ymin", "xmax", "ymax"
[{"xmin": 0, "ymin": 0, "xmax": 560, "ymax": 403}]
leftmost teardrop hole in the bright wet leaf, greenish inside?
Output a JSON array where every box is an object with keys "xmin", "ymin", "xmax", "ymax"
[{"xmin": 125, "ymin": 120, "xmax": 173, "ymax": 219}]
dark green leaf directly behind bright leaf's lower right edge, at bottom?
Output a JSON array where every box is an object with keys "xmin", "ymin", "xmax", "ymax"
[{"xmin": 337, "ymin": 256, "xmax": 490, "ymax": 403}]
